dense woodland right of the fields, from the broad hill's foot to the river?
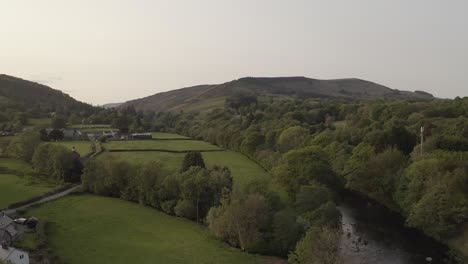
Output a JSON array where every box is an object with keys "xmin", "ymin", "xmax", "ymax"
[{"xmin": 144, "ymin": 95, "xmax": 468, "ymax": 260}]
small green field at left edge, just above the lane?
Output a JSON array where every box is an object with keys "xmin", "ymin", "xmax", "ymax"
[{"xmin": 0, "ymin": 158, "xmax": 56, "ymax": 208}]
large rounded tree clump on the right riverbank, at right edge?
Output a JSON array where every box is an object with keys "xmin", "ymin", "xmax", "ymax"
[{"xmin": 395, "ymin": 151, "xmax": 468, "ymax": 240}]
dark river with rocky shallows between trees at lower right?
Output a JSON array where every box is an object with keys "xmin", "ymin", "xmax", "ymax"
[{"xmin": 338, "ymin": 194, "xmax": 447, "ymax": 264}]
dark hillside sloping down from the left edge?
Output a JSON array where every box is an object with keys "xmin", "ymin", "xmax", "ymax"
[{"xmin": 0, "ymin": 74, "xmax": 93, "ymax": 113}]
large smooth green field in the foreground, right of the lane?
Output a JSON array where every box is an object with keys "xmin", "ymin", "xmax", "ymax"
[{"xmin": 27, "ymin": 195, "xmax": 262, "ymax": 264}]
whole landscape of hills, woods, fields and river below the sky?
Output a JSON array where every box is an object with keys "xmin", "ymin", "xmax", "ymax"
[{"xmin": 0, "ymin": 75, "xmax": 468, "ymax": 264}]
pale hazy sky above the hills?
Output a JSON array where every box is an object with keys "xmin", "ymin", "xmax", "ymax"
[{"xmin": 0, "ymin": 0, "xmax": 468, "ymax": 104}]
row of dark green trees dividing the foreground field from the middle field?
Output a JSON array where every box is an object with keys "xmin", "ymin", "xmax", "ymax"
[{"xmin": 82, "ymin": 156, "xmax": 232, "ymax": 225}]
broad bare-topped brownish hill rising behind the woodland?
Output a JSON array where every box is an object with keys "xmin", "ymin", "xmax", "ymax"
[{"xmin": 118, "ymin": 77, "xmax": 434, "ymax": 111}]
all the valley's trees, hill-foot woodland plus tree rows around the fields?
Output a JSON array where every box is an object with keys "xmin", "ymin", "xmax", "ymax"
[{"xmin": 0, "ymin": 76, "xmax": 468, "ymax": 263}]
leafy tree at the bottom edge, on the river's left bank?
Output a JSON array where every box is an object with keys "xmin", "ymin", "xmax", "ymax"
[{"xmin": 288, "ymin": 228, "xmax": 342, "ymax": 264}]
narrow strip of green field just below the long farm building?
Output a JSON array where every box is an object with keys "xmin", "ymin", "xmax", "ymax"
[{"xmin": 104, "ymin": 140, "xmax": 220, "ymax": 151}]
